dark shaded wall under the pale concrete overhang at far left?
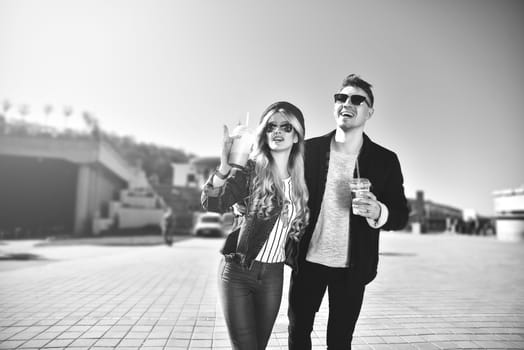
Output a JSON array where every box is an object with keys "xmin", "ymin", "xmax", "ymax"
[{"xmin": 0, "ymin": 155, "xmax": 77, "ymax": 237}]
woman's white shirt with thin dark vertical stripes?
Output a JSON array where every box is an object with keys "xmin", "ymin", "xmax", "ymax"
[{"xmin": 255, "ymin": 177, "xmax": 297, "ymax": 263}]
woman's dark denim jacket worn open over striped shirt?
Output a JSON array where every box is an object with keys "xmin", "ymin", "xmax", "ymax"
[{"xmin": 201, "ymin": 160, "xmax": 300, "ymax": 269}]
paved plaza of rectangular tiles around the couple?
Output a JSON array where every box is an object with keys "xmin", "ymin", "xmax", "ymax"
[{"xmin": 0, "ymin": 233, "xmax": 524, "ymax": 350}]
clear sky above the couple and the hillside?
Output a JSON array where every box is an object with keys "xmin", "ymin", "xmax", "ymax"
[{"xmin": 0, "ymin": 0, "xmax": 524, "ymax": 215}]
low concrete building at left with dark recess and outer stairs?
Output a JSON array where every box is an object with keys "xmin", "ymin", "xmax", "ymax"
[{"xmin": 0, "ymin": 130, "xmax": 163, "ymax": 237}]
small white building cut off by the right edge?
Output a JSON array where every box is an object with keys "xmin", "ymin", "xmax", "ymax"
[{"xmin": 493, "ymin": 185, "xmax": 524, "ymax": 241}]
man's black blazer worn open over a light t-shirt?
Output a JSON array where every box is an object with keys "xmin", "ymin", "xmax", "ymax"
[{"xmin": 298, "ymin": 131, "xmax": 409, "ymax": 284}]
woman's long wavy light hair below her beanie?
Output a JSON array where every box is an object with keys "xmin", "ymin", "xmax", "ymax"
[{"xmin": 250, "ymin": 106, "xmax": 309, "ymax": 238}]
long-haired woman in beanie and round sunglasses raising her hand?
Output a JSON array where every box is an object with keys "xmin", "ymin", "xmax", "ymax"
[{"xmin": 202, "ymin": 102, "xmax": 309, "ymax": 350}]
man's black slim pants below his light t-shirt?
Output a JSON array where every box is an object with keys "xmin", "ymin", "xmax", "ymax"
[{"xmin": 288, "ymin": 261, "xmax": 365, "ymax": 350}]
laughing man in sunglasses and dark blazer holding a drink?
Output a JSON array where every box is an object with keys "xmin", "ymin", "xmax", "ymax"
[{"xmin": 288, "ymin": 74, "xmax": 408, "ymax": 350}]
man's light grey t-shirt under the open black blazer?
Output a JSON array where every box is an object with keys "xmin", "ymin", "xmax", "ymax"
[{"xmin": 306, "ymin": 148, "xmax": 358, "ymax": 267}]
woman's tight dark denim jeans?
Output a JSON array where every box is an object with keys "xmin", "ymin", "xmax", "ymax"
[{"xmin": 218, "ymin": 259, "xmax": 284, "ymax": 350}]
